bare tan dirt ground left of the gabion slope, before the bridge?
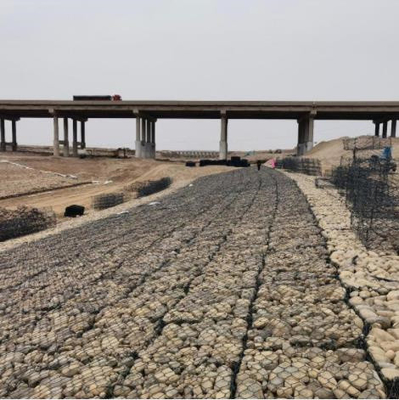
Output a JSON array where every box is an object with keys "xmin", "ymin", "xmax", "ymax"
[{"xmin": 0, "ymin": 153, "xmax": 238, "ymax": 217}]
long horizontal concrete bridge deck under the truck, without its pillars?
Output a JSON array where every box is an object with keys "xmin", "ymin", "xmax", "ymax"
[{"xmin": 0, "ymin": 100, "xmax": 399, "ymax": 120}]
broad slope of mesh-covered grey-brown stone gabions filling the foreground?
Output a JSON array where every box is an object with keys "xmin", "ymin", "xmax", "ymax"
[{"xmin": 0, "ymin": 168, "xmax": 385, "ymax": 398}]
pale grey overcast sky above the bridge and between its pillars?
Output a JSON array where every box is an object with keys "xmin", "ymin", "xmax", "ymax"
[{"xmin": 0, "ymin": 0, "xmax": 399, "ymax": 150}]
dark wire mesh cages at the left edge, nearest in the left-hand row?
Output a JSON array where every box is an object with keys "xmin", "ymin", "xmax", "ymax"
[{"xmin": 0, "ymin": 207, "xmax": 56, "ymax": 242}]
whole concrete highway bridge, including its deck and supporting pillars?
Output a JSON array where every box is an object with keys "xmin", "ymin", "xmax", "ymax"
[{"xmin": 0, "ymin": 100, "xmax": 399, "ymax": 159}]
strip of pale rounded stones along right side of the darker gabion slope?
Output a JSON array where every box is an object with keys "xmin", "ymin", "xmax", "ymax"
[{"xmin": 290, "ymin": 170, "xmax": 399, "ymax": 397}]
